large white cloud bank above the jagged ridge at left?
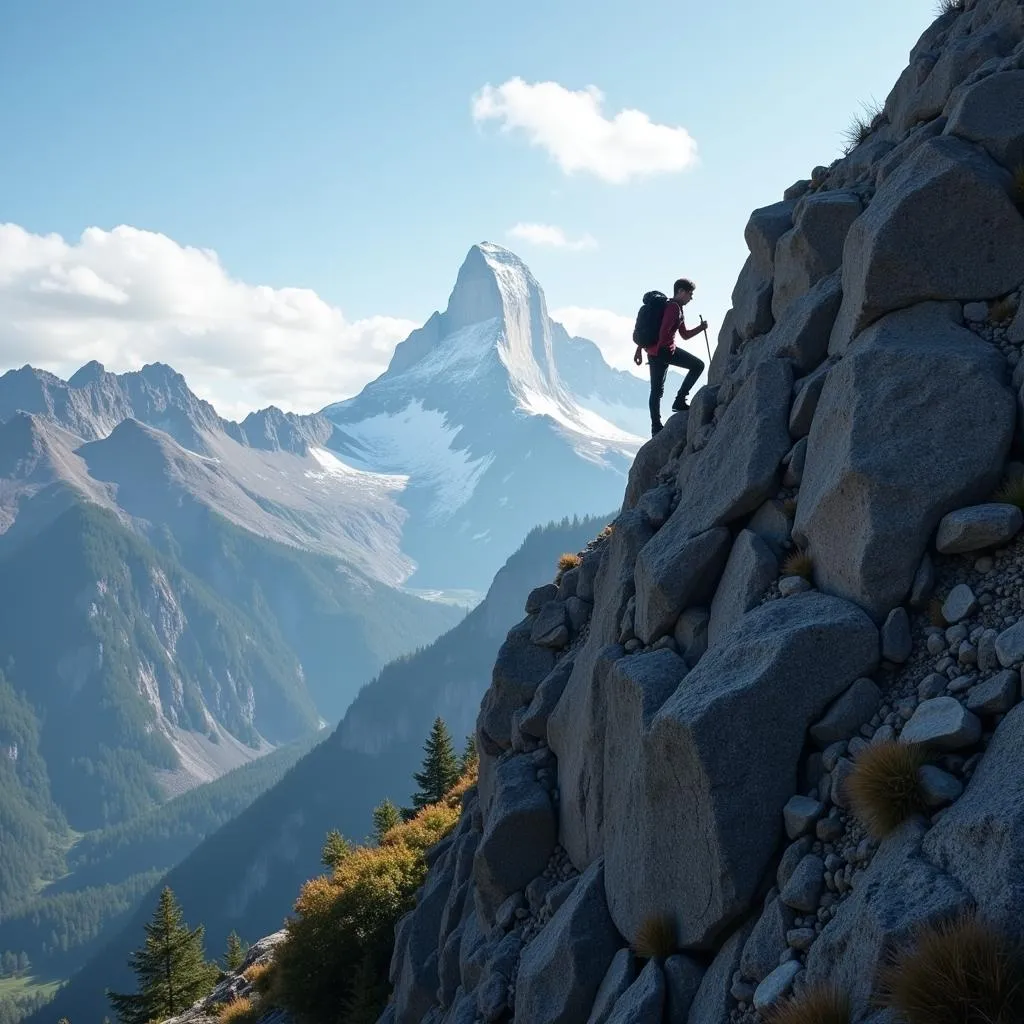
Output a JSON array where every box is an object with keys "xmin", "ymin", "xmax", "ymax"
[{"xmin": 0, "ymin": 223, "xmax": 418, "ymax": 418}]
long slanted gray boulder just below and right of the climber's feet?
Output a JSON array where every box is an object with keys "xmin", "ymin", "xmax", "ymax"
[{"xmin": 663, "ymin": 359, "xmax": 793, "ymax": 537}]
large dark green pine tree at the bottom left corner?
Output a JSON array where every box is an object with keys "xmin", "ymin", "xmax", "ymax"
[{"xmin": 106, "ymin": 888, "xmax": 217, "ymax": 1024}]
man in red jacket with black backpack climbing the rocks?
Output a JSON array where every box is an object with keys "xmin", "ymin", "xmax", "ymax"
[{"xmin": 633, "ymin": 278, "xmax": 708, "ymax": 437}]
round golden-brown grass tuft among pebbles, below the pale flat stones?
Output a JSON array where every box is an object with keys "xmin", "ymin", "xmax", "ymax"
[{"xmin": 846, "ymin": 740, "xmax": 928, "ymax": 839}]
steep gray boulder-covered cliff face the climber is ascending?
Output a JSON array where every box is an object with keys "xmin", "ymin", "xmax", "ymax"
[{"xmin": 382, "ymin": 0, "xmax": 1024, "ymax": 1024}]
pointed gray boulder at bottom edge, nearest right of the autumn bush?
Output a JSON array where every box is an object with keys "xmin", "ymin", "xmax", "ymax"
[{"xmin": 514, "ymin": 859, "xmax": 622, "ymax": 1024}]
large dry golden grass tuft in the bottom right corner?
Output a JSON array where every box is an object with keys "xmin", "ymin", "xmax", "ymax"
[{"xmin": 880, "ymin": 911, "xmax": 1024, "ymax": 1024}]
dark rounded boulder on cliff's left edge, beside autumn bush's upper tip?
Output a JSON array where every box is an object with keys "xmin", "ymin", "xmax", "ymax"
[{"xmin": 473, "ymin": 755, "xmax": 558, "ymax": 918}]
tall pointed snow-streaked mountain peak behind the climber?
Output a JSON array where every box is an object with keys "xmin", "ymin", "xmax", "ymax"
[{"xmin": 323, "ymin": 243, "xmax": 646, "ymax": 587}]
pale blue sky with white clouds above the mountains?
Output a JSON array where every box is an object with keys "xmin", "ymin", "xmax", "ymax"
[{"xmin": 0, "ymin": 0, "xmax": 934, "ymax": 413}]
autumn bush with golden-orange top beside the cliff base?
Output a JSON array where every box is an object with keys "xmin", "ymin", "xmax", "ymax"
[{"xmin": 273, "ymin": 770, "xmax": 476, "ymax": 1024}]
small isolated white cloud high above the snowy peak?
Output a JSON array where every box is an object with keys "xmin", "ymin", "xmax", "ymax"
[{"xmin": 472, "ymin": 78, "xmax": 697, "ymax": 184}]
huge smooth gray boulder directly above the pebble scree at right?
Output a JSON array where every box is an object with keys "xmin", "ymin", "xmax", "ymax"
[{"xmin": 794, "ymin": 299, "xmax": 1011, "ymax": 622}]
